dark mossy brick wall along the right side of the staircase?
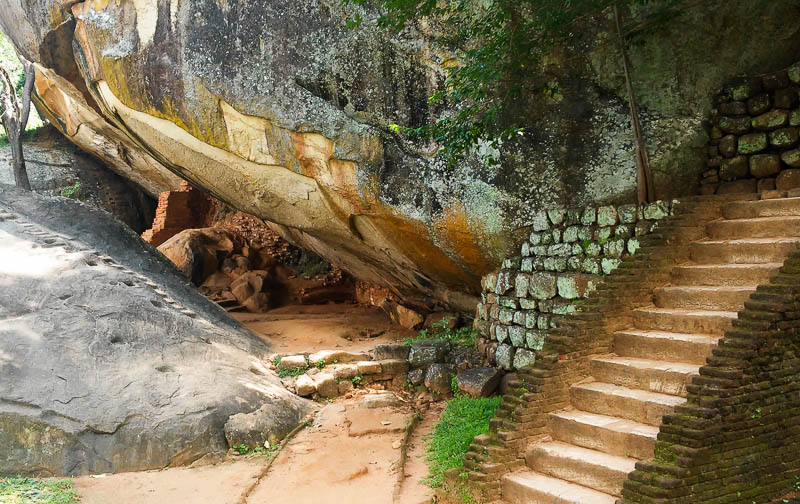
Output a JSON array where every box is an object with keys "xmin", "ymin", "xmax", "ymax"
[{"xmin": 622, "ymin": 253, "xmax": 800, "ymax": 504}]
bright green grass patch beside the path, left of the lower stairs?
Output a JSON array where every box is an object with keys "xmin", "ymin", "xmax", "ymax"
[{"xmin": 424, "ymin": 396, "xmax": 503, "ymax": 488}]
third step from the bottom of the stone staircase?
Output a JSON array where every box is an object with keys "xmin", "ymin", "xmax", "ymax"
[{"xmin": 549, "ymin": 410, "xmax": 658, "ymax": 459}]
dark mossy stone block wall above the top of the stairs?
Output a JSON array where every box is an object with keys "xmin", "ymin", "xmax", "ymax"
[{"xmin": 701, "ymin": 63, "xmax": 800, "ymax": 194}]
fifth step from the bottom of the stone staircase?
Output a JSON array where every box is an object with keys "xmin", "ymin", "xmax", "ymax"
[{"xmin": 591, "ymin": 354, "xmax": 710, "ymax": 397}]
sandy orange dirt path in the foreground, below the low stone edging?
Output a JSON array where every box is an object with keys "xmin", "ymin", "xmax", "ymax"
[{"xmin": 75, "ymin": 392, "xmax": 441, "ymax": 504}]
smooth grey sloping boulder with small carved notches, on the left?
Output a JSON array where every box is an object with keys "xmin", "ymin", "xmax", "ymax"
[{"xmin": 0, "ymin": 185, "xmax": 313, "ymax": 476}]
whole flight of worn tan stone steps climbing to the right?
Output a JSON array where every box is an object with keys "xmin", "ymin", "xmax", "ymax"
[{"xmin": 501, "ymin": 198, "xmax": 800, "ymax": 504}]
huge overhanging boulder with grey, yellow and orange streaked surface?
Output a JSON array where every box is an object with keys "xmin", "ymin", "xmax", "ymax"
[{"xmin": 0, "ymin": 0, "xmax": 800, "ymax": 307}]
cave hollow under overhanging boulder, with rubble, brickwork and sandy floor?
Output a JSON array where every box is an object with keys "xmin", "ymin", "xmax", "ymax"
[{"xmin": 142, "ymin": 182, "xmax": 420, "ymax": 354}]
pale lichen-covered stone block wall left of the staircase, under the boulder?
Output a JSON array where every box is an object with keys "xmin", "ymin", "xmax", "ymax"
[{"xmin": 475, "ymin": 201, "xmax": 672, "ymax": 369}]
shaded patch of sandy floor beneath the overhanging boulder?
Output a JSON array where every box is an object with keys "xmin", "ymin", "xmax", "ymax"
[{"xmin": 231, "ymin": 303, "xmax": 418, "ymax": 354}]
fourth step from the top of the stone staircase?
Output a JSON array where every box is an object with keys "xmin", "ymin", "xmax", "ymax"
[{"xmin": 672, "ymin": 263, "xmax": 782, "ymax": 286}]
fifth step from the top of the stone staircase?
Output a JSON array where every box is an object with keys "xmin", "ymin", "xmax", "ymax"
[{"xmin": 653, "ymin": 285, "xmax": 758, "ymax": 311}]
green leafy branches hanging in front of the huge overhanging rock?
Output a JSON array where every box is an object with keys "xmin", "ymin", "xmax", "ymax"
[{"xmin": 341, "ymin": 0, "xmax": 683, "ymax": 165}]
